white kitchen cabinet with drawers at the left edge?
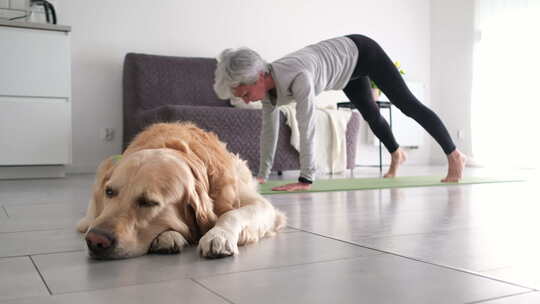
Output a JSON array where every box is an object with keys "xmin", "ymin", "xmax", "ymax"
[{"xmin": 0, "ymin": 22, "xmax": 71, "ymax": 178}]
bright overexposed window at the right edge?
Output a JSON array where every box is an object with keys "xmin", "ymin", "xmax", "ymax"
[{"xmin": 472, "ymin": 0, "xmax": 540, "ymax": 168}]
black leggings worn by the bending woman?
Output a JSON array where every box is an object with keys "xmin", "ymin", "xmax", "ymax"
[{"xmin": 343, "ymin": 35, "xmax": 456, "ymax": 155}]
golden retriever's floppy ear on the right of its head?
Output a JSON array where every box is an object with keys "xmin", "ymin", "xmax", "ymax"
[{"xmin": 184, "ymin": 156, "xmax": 217, "ymax": 235}]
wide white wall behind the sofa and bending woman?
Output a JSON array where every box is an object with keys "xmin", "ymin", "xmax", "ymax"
[{"xmin": 56, "ymin": 0, "xmax": 431, "ymax": 172}]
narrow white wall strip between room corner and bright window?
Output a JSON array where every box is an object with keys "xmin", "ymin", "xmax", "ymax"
[{"xmin": 431, "ymin": 0, "xmax": 474, "ymax": 164}]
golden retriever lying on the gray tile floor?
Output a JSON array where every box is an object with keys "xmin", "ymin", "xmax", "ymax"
[{"xmin": 77, "ymin": 123, "xmax": 286, "ymax": 259}]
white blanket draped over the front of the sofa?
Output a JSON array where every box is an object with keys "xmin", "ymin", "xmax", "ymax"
[{"xmin": 280, "ymin": 103, "xmax": 351, "ymax": 174}]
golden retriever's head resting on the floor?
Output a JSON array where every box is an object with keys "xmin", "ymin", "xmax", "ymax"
[{"xmin": 86, "ymin": 143, "xmax": 216, "ymax": 259}]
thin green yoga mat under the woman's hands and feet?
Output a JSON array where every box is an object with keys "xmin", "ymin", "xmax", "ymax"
[{"xmin": 259, "ymin": 176, "xmax": 524, "ymax": 194}]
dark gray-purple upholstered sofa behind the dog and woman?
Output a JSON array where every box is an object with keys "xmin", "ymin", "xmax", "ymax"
[{"xmin": 123, "ymin": 53, "xmax": 360, "ymax": 174}]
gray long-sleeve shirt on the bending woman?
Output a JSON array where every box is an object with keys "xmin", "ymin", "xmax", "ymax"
[{"xmin": 258, "ymin": 37, "xmax": 358, "ymax": 180}]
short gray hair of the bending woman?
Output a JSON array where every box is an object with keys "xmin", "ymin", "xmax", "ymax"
[{"xmin": 214, "ymin": 48, "xmax": 269, "ymax": 99}]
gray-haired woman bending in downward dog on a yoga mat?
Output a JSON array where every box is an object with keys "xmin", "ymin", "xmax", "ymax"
[{"xmin": 214, "ymin": 35, "xmax": 466, "ymax": 191}]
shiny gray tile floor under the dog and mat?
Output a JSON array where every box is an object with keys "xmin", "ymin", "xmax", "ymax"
[{"xmin": 0, "ymin": 166, "xmax": 540, "ymax": 304}]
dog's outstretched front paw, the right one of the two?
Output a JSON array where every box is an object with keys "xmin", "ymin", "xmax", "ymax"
[{"xmin": 198, "ymin": 227, "xmax": 238, "ymax": 259}]
